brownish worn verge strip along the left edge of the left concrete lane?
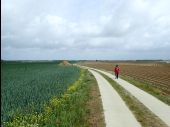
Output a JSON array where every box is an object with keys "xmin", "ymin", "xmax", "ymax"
[{"xmin": 87, "ymin": 73, "xmax": 106, "ymax": 127}]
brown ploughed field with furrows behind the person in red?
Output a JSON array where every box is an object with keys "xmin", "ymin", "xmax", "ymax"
[{"xmin": 80, "ymin": 61, "xmax": 170, "ymax": 96}]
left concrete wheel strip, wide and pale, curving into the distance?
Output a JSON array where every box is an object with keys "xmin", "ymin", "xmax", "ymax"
[{"xmin": 89, "ymin": 69, "xmax": 141, "ymax": 127}]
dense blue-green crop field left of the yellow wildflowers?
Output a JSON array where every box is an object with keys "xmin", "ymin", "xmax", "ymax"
[{"xmin": 1, "ymin": 62, "xmax": 80, "ymax": 121}]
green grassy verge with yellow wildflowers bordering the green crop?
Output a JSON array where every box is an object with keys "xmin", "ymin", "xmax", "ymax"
[{"xmin": 3, "ymin": 70, "xmax": 102, "ymax": 127}]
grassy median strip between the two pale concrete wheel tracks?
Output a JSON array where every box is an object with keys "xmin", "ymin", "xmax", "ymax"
[{"xmin": 99, "ymin": 72, "xmax": 167, "ymax": 127}]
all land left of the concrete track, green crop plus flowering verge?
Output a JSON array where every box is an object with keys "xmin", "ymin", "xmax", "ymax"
[{"xmin": 1, "ymin": 61, "xmax": 105, "ymax": 127}]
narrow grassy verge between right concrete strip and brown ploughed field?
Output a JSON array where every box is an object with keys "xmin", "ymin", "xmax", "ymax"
[{"xmin": 121, "ymin": 76, "xmax": 170, "ymax": 105}]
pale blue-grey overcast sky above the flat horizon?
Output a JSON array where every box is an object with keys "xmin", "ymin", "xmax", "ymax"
[{"xmin": 1, "ymin": 0, "xmax": 170, "ymax": 60}]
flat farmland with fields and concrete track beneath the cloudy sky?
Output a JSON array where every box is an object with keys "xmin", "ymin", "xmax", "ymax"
[{"xmin": 1, "ymin": 60, "xmax": 170, "ymax": 127}]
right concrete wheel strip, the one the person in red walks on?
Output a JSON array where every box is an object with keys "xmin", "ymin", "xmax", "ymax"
[{"xmin": 79, "ymin": 67, "xmax": 170, "ymax": 127}]
